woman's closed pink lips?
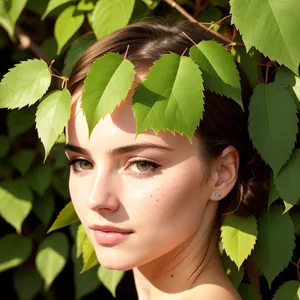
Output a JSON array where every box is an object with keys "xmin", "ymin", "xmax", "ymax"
[{"xmin": 89, "ymin": 225, "xmax": 133, "ymax": 246}]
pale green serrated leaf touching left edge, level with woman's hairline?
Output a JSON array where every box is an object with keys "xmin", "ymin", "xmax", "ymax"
[{"xmin": 0, "ymin": 59, "xmax": 51, "ymax": 109}]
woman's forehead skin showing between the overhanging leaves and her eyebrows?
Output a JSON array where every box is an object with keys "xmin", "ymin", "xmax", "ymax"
[{"xmin": 67, "ymin": 84, "xmax": 200, "ymax": 154}]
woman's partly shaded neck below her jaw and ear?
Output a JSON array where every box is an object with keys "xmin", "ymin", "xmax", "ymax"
[{"xmin": 133, "ymin": 201, "xmax": 231, "ymax": 300}]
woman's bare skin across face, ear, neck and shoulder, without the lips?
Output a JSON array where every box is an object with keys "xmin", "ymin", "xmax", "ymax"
[{"xmin": 66, "ymin": 79, "xmax": 241, "ymax": 300}]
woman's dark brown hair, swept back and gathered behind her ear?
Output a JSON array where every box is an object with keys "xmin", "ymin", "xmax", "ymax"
[{"xmin": 68, "ymin": 21, "xmax": 269, "ymax": 217}]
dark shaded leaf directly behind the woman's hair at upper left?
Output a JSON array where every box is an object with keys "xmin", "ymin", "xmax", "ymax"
[{"xmin": 62, "ymin": 34, "xmax": 96, "ymax": 76}]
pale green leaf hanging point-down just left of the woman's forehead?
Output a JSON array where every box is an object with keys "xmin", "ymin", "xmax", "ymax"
[{"xmin": 36, "ymin": 89, "xmax": 72, "ymax": 160}]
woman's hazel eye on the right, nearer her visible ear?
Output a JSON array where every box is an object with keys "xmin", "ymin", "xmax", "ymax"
[{"xmin": 125, "ymin": 158, "xmax": 161, "ymax": 178}]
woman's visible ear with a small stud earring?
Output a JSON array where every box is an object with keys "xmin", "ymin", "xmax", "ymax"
[{"xmin": 210, "ymin": 146, "xmax": 240, "ymax": 200}]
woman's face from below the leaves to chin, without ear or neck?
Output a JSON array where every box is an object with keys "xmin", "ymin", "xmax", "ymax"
[{"xmin": 66, "ymin": 84, "xmax": 217, "ymax": 270}]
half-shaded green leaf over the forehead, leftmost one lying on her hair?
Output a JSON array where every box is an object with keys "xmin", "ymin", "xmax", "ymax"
[{"xmin": 82, "ymin": 52, "xmax": 134, "ymax": 134}]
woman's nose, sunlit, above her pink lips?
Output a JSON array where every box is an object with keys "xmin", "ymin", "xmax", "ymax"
[{"xmin": 88, "ymin": 169, "xmax": 120, "ymax": 213}]
